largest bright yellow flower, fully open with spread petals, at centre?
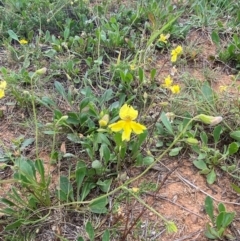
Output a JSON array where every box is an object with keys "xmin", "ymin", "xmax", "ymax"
[{"xmin": 109, "ymin": 104, "xmax": 147, "ymax": 141}]
